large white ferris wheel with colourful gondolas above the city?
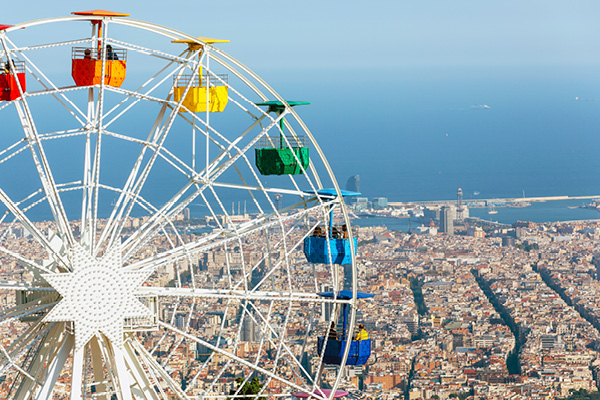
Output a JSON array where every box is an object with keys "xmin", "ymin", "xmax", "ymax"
[{"xmin": 0, "ymin": 10, "xmax": 370, "ymax": 400}]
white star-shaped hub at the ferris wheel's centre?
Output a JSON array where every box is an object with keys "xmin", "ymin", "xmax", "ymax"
[{"xmin": 42, "ymin": 244, "xmax": 152, "ymax": 349}]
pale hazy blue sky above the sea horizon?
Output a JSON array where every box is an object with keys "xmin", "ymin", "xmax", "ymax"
[{"xmin": 0, "ymin": 0, "xmax": 600, "ymax": 70}]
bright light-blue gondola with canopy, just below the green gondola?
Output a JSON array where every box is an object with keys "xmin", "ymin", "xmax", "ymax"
[{"xmin": 304, "ymin": 189, "xmax": 360, "ymax": 265}]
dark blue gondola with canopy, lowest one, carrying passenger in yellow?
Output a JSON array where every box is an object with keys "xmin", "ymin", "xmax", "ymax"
[{"xmin": 317, "ymin": 290, "xmax": 373, "ymax": 365}]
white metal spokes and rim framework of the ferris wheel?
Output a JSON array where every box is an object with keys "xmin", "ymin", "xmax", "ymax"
[{"xmin": 0, "ymin": 15, "xmax": 358, "ymax": 399}]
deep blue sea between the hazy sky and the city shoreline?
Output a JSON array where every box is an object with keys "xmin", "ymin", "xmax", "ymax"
[{"xmin": 0, "ymin": 65, "xmax": 600, "ymax": 226}]
